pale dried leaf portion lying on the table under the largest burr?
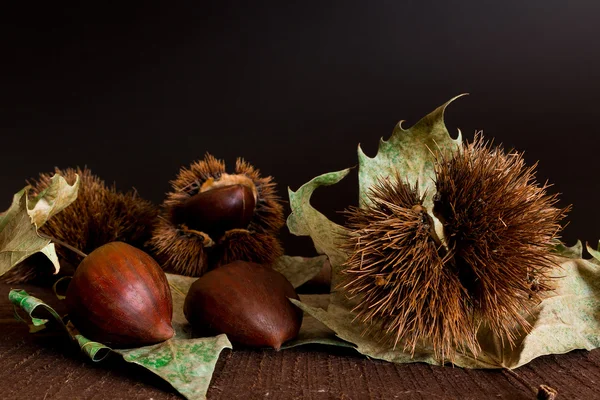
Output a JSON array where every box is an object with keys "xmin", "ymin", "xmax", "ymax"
[{"xmin": 292, "ymin": 252, "xmax": 600, "ymax": 369}]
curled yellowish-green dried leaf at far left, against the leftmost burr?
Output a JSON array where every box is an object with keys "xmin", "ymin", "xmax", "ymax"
[{"xmin": 0, "ymin": 175, "xmax": 79, "ymax": 276}]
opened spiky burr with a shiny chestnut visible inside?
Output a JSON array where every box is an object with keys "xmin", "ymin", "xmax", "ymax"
[{"xmin": 150, "ymin": 154, "xmax": 284, "ymax": 276}]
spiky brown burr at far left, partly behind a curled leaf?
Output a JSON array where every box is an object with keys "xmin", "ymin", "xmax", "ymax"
[{"xmin": 3, "ymin": 168, "xmax": 158, "ymax": 283}]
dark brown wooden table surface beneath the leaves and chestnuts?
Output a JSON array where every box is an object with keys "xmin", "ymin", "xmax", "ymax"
[{"xmin": 0, "ymin": 284, "xmax": 600, "ymax": 400}]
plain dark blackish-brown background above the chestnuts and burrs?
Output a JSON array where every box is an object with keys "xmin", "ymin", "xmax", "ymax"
[{"xmin": 0, "ymin": 0, "xmax": 600, "ymax": 253}]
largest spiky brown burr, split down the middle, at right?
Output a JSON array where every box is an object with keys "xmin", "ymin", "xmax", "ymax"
[{"xmin": 344, "ymin": 135, "xmax": 568, "ymax": 359}]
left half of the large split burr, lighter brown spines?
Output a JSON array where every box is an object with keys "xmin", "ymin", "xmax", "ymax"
[{"xmin": 343, "ymin": 176, "xmax": 477, "ymax": 357}]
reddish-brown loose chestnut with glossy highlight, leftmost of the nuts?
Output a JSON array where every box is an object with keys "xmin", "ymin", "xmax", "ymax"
[{"xmin": 66, "ymin": 242, "xmax": 174, "ymax": 347}]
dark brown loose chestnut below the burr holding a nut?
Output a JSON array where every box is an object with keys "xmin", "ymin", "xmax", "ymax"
[{"xmin": 183, "ymin": 261, "xmax": 302, "ymax": 349}]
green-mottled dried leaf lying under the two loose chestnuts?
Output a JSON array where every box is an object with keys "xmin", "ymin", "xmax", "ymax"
[{"xmin": 8, "ymin": 288, "xmax": 231, "ymax": 400}]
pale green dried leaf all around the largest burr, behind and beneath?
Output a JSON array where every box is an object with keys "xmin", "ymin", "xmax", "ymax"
[{"xmin": 288, "ymin": 95, "xmax": 600, "ymax": 368}]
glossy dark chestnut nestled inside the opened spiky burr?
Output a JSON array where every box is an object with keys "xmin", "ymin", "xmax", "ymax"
[{"xmin": 172, "ymin": 184, "xmax": 256, "ymax": 239}]
